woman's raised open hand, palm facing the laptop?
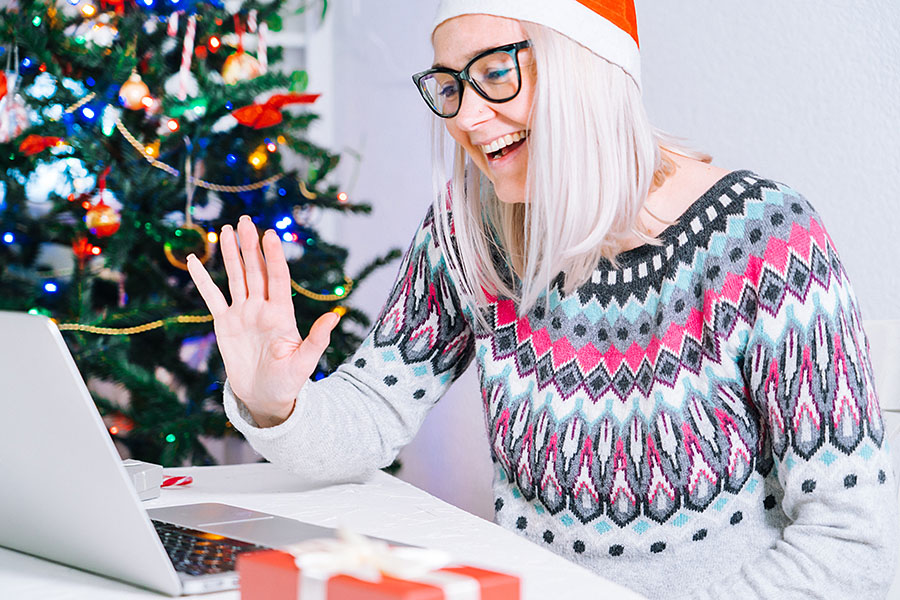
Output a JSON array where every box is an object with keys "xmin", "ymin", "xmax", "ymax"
[{"xmin": 187, "ymin": 216, "xmax": 340, "ymax": 427}]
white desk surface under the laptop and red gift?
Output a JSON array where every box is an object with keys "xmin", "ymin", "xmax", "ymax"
[{"xmin": 0, "ymin": 464, "xmax": 641, "ymax": 600}]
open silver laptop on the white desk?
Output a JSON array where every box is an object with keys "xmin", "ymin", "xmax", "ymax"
[{"xmin": 0, "ymin": 311, "xmax": 344, "ymax": 596}]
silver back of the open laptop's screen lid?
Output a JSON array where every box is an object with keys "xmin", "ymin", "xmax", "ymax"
[{"xmin": 0, "ymin": 311, "xmax": 181, "ymax": 596}]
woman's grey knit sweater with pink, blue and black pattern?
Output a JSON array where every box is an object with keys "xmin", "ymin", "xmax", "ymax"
[{"xmin": 226, "ymin": 171, "xmax": 896, "ymax": 599}]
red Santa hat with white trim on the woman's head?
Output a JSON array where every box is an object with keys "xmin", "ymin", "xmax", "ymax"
[{"xmin": 434, "ymin": 0, "xmax": 641, "ymax": 87}]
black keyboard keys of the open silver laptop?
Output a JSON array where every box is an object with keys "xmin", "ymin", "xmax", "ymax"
[{"xmin": 153, "ymin": 521, "xmax": 268, "ymax": 575}]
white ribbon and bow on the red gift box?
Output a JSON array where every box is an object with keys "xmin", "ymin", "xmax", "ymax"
[{"xmin": 283, "ymin": 529, "xmax": 481, "ymax": 600}]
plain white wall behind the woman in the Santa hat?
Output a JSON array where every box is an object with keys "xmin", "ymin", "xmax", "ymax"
[{"xmin": 324, "ymin": 0, "xmax": 900, "ymax": 517}]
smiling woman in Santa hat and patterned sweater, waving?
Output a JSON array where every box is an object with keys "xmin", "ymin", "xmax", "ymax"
[{"xmin": 189, "ymin": 0, "xmax": 896, "ymax": 598}]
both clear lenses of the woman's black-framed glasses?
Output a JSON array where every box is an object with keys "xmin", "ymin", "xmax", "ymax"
[{"xmin": 419, "ymin": 52, "xmax": 520, "ymax": 115}]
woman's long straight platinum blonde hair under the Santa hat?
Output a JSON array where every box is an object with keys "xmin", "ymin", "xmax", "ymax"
[{"xmin": 433, "ymin": 22, "xmax": 709, "ymax": 327}]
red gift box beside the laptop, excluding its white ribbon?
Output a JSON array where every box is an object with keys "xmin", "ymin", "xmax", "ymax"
[{"xmin": 237, "ymin": 550, "xmax": 519, "ymax": 600}]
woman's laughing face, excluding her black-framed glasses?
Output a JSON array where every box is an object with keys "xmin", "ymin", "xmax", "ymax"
[{"xmin": 432, "ymin": 15, "xmax": 534, "ymax": 203}]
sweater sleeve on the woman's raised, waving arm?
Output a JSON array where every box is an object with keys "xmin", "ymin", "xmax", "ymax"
[{"xmin": 225, "ymin": 211, "xmax": 474, "ymax": 483}]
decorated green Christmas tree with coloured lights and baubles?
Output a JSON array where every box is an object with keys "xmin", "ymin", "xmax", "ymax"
[{"xmin": 0, "ymin": 0, "xmax": 397, "ymax": 465}]
